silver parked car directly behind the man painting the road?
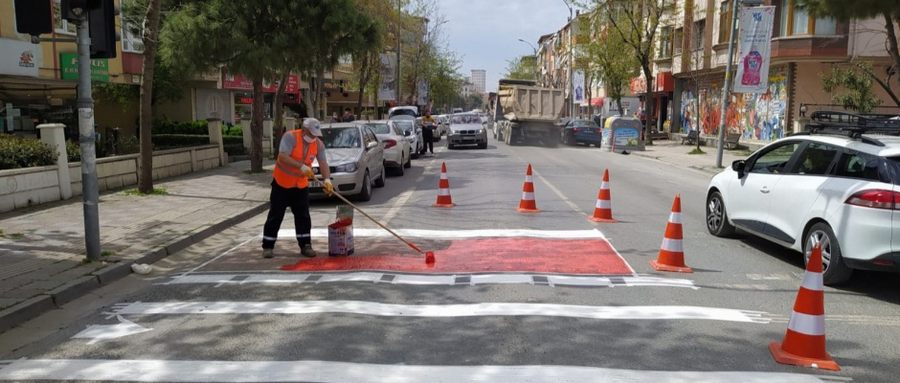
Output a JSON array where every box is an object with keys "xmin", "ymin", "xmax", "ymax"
[{"xmin": 309, "ymin": 122, "xmax": 385, "ymax": 201}]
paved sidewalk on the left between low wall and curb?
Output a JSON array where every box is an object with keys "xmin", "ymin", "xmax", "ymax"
[{"xmin": 0, "ymin": 161, "xmax": 271, "ymax": 332}]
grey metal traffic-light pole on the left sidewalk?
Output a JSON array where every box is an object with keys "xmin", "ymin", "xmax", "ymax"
[{"xmin": 76, "ymin": 10, "xmax": 100, "ymax": 261}]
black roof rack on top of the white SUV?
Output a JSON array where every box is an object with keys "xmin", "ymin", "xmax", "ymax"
[{"xmin": 804, "ymin": 111, "xmax": 900, "ymax": 146}]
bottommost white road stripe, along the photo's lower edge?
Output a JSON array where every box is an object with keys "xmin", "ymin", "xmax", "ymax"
[{"xmin": 0, "ymin": 359, "xmax": 850, "ymax": 383}]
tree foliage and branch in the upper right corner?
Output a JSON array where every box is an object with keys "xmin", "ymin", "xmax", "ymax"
[{"xmin": 797, "ymin": 0, "xmax": 900, "ymax": 107}]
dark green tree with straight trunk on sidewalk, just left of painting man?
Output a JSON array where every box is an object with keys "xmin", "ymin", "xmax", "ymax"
[{"xmin": 161, "ymin": 0, "xmax": 314, "ymax": 172}]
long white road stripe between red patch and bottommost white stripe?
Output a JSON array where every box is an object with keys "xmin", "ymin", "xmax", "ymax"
[{"xmin": 115, "ymin": 300, "xmax": 769, "ymax": 323}]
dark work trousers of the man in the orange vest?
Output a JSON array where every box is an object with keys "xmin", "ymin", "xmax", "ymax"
[{"xmin": 263, "ymin": 180, "xmax": 312, "ymax": 249}]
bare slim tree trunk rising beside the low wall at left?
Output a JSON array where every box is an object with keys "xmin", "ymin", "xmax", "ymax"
[{"xmin": 138, "ymin": 0, "xmax": 161, "ymax": 194}]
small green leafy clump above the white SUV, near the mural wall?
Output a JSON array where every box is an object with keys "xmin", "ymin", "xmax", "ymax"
[{"xmin": 822, "ymin": 62, "xmax": 881, "ymax": 113}]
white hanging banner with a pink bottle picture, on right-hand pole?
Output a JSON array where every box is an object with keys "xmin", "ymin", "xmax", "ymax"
[{"xmin": 734, "ymin": 6, "xmax": 775, "ymax": 93}]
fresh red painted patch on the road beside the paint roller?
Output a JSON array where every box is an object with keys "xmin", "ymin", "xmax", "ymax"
[{"xmin": 282, "ymin": 238, "xmax": 633, "ymax": 275}]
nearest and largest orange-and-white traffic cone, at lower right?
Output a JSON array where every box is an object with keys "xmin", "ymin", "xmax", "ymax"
[{"xmin": 769, "ymin": 243, "xmax": 841, "ymax": 371}]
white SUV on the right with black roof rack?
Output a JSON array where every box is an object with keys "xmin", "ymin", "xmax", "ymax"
[{"xmin": 706, "ymin": 113, "xmax": 900, "ymax": 284}]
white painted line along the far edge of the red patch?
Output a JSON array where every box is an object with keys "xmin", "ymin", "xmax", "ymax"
[{"xmin": 278, "ymin": 228, "xmax": 606, "ymax": 239}]
